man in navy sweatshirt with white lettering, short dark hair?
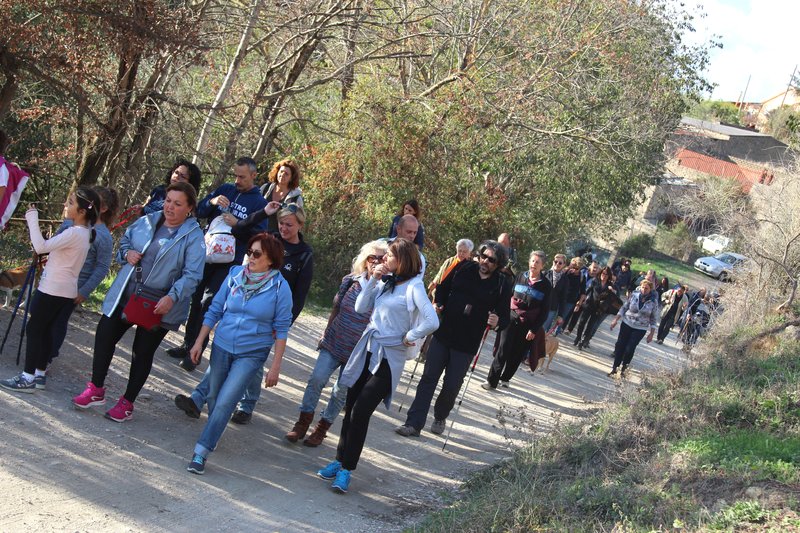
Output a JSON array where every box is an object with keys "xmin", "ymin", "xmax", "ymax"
[{"xmin": 167, "ymin": 157, "xmax": 267, "ymax": 372}]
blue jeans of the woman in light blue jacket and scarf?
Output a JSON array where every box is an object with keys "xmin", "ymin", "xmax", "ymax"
[{"xmin": 192, "ymin": 343, "xmax": 267, "ymax": 457}]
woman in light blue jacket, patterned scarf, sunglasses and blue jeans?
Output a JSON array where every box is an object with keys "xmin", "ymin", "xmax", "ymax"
[{"xmin": 187, "ymin": 233, "xmax": 292, "ymax": 474}]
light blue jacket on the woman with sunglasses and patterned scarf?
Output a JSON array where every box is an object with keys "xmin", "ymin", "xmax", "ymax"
[{"xmin": 203, "ymin": 266, "xmax": 292, "ymax": 357}]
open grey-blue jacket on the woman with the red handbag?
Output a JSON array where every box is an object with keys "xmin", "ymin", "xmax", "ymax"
[{"xmin": 103, "ymin": 211, "xmax": 206, "ymax": 326}]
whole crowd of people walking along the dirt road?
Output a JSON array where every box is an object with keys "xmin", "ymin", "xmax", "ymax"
[{"xmin": 0, "ymin": 154, "xmax": 712, "ymax": 492}]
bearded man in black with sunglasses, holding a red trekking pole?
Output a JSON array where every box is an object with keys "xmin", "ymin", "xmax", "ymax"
[{"xmin": 395, "ymin": 241, "xmax": 511, "ymax": 437}]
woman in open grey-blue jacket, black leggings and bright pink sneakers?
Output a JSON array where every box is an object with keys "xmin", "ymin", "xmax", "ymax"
[{"xmin": 72, "ymin": 182, "xmax": 205, "ymax": 422}]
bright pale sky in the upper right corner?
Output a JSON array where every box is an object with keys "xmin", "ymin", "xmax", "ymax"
[{"xmin": 686, "ymin": 0, "xmax": 800, "ymax": 102}]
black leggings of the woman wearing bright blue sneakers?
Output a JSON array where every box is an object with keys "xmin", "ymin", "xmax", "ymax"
[{"xmin": 336, "ymin": 354, "xmax": 392, "ymax": 470}]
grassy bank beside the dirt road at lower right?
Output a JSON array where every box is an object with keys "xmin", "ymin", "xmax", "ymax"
[{"xmin": 414, "ymin": 324, "xmax": 800, "ymax": 531}]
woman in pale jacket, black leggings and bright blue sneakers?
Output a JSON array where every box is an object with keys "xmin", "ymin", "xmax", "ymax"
[{"xmin": 317, "ymin": 239, "xmax": 439, "ymax": 492}]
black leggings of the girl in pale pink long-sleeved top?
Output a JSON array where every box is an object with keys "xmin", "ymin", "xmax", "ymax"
[{"xmin": 25, "ymin": 289, "xmax": 75, "ymax": 374}]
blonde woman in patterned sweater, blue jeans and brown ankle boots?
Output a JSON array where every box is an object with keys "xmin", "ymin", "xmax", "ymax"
[{"xmin": 286, "ymin": 240, "xmax": 388, "ymax": 447}]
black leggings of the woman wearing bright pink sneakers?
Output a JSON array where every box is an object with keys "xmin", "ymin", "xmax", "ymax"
[{"xmin": 92, "ymin": 304, "xmax": 167, "ymax": 403}]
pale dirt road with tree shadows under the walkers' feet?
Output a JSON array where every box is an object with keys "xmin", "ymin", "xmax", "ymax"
[{"xmin": 0, "ymin": 309, "xmax": 685, "ymax": 532}]
